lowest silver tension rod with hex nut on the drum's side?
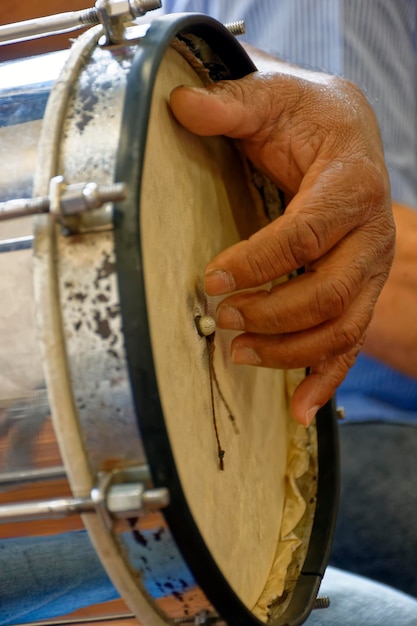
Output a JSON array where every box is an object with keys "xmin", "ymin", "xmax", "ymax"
[{"xmin": 0, "ymin": 470, "xmax": 169, "ymax": 526}]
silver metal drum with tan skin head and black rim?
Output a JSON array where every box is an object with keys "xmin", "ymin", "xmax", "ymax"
[{"xmin": 0, "ymin": 9, "xmax": 338, "ymax": 626}]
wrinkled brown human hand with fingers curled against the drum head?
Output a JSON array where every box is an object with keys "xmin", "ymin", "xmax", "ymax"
[{"xmin": 171, "ymin": 48, "xmax": 395, "ymax": 425}]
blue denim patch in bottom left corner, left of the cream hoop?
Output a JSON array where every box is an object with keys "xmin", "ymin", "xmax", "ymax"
[{"xmin": 0, "ymin": 531, "xmax": 118, "ymax": 625}]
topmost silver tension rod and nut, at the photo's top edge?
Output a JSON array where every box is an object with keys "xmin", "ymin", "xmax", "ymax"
[{"xmin": 0, "ymin": 0, "xmax": 161, "ymax": 46}]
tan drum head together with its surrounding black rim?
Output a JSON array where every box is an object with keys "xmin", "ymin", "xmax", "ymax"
[{"xmin": 115, "ymin": 15, "xmax": 338, "ymax": 624}]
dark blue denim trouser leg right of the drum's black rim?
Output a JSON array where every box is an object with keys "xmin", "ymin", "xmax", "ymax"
[{"xmin": 331, "ymin": 423, "xmax": 417, "ymax": 596}]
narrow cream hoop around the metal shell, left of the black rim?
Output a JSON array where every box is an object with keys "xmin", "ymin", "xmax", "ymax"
[{"xmin": 33, "ymin": 26, "xmax": 171, "ymax": 626}]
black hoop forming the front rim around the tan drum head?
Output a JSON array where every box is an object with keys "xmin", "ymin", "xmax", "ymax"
[{"xmin": 115, "ymin": 13, "xmax": 339, "ymax": 626}]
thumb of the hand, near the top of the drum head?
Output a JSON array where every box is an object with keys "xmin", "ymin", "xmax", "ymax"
[{"xmin": 170, "ymin": 76, "xmax": 272, "ymax": 139}]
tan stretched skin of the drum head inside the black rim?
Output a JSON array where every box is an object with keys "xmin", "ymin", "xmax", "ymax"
[{"xmin": 140, "ymin": 45, "xmax": 288, "ymax": 607}]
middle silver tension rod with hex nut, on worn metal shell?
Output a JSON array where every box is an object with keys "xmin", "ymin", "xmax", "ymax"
[{"xmin": 0, "ymin": 176, "xmax": 126, "ymax": 232}]
